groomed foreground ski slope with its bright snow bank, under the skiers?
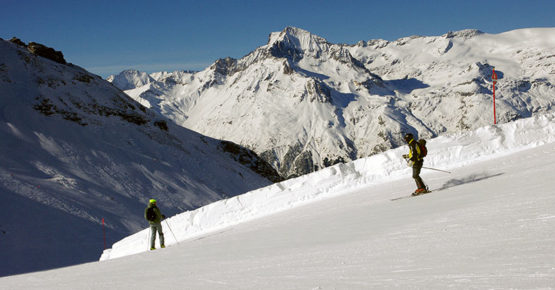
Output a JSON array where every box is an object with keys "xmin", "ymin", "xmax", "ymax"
[{"xmin": 0, "ymin": 114, "xmax": 555, "ymax": 289}]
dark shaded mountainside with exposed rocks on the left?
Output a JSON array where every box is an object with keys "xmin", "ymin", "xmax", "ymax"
[{"xmin": 0, "ymin": 40, "xmax": 277, "ymax": 276}]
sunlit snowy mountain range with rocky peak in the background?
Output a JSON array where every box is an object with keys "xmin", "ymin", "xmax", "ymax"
[{"xmin": 110, "ymin": 27, "xmax": 555, "ymax": 177}]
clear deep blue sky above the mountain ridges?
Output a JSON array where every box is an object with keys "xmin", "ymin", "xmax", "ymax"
[{"xmin": 0, "ymin": 0, "xmax": 555, "ymax": 77}]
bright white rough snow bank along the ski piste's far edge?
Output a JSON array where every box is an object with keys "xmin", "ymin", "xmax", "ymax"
[{"xmin": 100, "ymin": 113, "xmax": 555, "ymax": 260}]
